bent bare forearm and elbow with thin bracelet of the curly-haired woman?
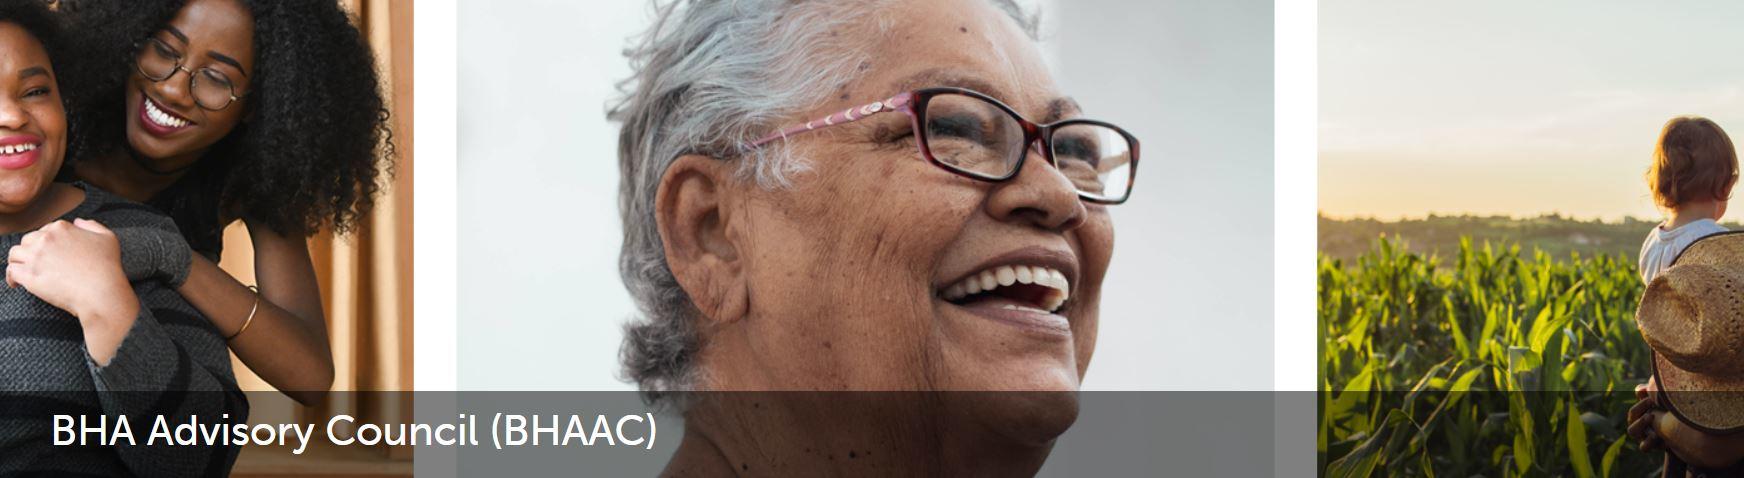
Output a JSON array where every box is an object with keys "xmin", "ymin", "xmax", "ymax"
[{"xmin": 178, "ymin": 222, "xmax": 333, "ymax": 405}]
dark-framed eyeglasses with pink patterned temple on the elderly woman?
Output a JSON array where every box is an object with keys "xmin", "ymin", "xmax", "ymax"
[{"xmin": 746, "ymin": 87, "xmax": 1139, "ymax": 204}]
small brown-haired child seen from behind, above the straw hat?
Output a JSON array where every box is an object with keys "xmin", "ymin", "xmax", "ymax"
[{"xmin": 1639, "ymin": 117, "xmax": 1739, "ymax": 284}]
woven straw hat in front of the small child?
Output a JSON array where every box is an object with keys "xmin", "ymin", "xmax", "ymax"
[{"xmin": 1636, "ymin": 232, "xmax": 1744, "ymax": 433}]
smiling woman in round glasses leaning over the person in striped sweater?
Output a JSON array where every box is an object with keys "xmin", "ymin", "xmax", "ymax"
[{"xmin": 38, "ymin": 0, "xmax": 392, "ymax": 405}]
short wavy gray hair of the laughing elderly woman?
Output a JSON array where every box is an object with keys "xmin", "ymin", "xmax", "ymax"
[{"xmin": 607, "ymin": 0, "xmax": 1038, "ymax": 401}]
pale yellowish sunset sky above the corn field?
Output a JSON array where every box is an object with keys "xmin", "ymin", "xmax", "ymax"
[{"xmin": 1318, "ymin": 0, "xmax": 1744, "ymax": 220}]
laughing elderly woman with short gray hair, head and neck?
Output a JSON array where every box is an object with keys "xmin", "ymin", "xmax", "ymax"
[{"xmin": 612, "ymin": 0, "xmax": 1139, "ymax": 476}]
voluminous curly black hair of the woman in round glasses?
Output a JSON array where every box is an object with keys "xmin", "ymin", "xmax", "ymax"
[{"xmin": 59, "ymin": 0, "xmax": 394, "ymax": 249}]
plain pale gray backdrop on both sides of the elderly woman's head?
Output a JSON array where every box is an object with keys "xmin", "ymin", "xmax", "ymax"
[{"xmin": 457, "ymin": 0, "xmax": 1273, "ymax": 391}]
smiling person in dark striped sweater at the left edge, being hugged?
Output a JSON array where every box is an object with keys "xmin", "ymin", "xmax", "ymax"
[{"xmin": 0, "ymin": 0, "xmax": 248, "ymax": 476}]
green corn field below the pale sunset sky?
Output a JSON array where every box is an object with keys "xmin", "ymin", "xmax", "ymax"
[{"xmin": 1318, "ymin": 236, "xmax": 1662, "ymax": 476}]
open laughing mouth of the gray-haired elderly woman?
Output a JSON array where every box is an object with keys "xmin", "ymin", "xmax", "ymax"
[{"xmin": 938, "ymin": 265, "xmax": 1071, "ymax": 314}]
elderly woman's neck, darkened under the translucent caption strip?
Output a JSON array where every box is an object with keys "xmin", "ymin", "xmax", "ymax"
[{"xmin": 663, "ymin": 393, "xmax": 1053, "ymax": 476}]
